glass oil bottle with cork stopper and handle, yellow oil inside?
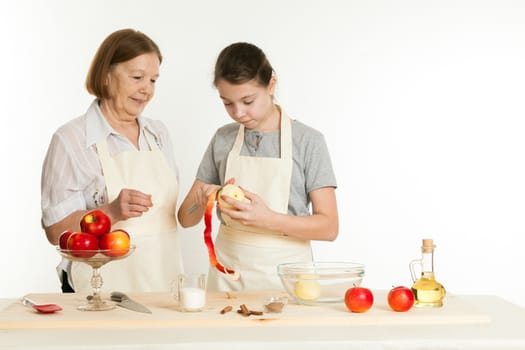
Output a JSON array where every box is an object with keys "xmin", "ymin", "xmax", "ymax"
[{"xmin": 410, "ymin": 239, "xmax": 446, "ymax": 308}]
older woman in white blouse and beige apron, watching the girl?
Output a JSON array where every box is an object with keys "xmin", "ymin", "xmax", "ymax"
[{"xmin": 42, "ymin": 29, "xmax": 182, "ymax": 292}]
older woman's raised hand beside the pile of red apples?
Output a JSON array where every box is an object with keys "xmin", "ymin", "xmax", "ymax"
[{"xmin": 107, "ymin": 188, "xmax": 153, "ymax": 222}]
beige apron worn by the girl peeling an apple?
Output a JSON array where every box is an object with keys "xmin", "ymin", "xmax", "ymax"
[{"xmin": 208, "ymin": 112, "xmax": 312, "ymax": 291}]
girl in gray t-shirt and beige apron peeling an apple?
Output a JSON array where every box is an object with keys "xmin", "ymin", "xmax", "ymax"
[{"xmin": 178, "ymin": 43, "xmax": 338, "ymax": 291}]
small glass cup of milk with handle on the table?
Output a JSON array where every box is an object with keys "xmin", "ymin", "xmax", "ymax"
[{"xmin": 173, "ymin": 273, "xmax": 206, "ymax": 312}]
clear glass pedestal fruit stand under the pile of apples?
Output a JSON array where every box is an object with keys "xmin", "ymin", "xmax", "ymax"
[{"xmin": 57, "ymin": 245, "xmax": 135, "ymax": 311}]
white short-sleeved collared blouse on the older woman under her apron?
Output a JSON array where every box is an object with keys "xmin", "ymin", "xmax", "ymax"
[{"xmin": 41, "ymin": 100, "xmax": 179, "ymax": 227}]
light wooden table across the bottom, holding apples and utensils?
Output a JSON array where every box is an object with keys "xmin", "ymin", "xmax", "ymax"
[{"xmin": 0, "ymin": 291, "xmax": 525, "ymax": 350}]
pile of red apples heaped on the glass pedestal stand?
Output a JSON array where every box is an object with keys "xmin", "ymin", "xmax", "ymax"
[{"xmin": 58, "ymin": 209, "xmax": 130, "ymax": 258}]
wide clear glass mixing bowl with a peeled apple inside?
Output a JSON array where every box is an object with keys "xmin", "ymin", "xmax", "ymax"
[{"xmin": 277, "ymin": 262, "xmax": 365, "ymax": 305}]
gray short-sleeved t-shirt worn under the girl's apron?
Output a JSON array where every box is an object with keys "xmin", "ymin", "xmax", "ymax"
[{"xmin": 197, "ymin": 120, "xmax": 337, "ymax": 216}]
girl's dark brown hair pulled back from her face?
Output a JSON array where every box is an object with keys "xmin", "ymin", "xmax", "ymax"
[{"xmin": 213, "ymin": 42, "xmax": 274, "ymax": 87}]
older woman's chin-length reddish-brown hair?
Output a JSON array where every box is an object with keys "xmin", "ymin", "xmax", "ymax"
[{"xmin": 86, "ymin": 29, "xmax": 162, "ymax": 99}]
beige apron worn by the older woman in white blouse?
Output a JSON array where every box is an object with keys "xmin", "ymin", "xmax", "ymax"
[{"xmin": 72, "ymin": 131, "xmax": 183, "ymax": 292}]
